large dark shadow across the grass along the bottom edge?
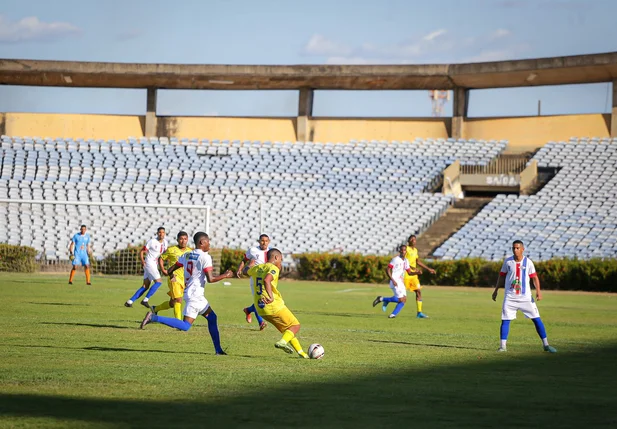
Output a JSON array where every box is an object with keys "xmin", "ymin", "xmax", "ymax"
[{"xmin": 0, "ymin": 345, "xmax": 617, "ymax": 429}]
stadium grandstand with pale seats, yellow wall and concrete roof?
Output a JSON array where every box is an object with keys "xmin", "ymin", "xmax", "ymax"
[{"xmin": 0, "ymin": 53, "xmax": 617, "ymax": 270}]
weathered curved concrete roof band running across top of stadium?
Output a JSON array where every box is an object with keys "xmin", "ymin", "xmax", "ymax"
[{"xmin": 0, "ymin": 52, "xmax": 617, "ymax": 90}]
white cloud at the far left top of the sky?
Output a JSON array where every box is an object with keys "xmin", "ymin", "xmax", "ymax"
[{"xmin": 0, "ymin": 15, "xmax": 81, "ymax": 43}]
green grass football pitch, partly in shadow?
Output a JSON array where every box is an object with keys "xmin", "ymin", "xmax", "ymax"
[{"xmin": 0, "ymin": 273, "xmax": 617, "ymax": 428}]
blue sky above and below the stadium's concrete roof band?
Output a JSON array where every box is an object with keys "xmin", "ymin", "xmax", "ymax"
[{"xmin": 0, "ymin": 0, "xmax": 617, "ymax": 117}]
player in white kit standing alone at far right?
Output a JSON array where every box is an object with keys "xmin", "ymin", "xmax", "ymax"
[{"xmin": 493, "ymin": 240, "xmax": 557, "ymax": 353}]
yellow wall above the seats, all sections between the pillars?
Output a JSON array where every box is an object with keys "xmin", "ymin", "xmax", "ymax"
[{"xmin": 0, "ymin": 113, "xmax": 610, "ymax": 152}]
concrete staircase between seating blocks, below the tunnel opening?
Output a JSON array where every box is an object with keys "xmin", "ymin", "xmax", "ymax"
[{"xmin": 418, "ymin": 197, "xmax": 493, "ymax": 258}]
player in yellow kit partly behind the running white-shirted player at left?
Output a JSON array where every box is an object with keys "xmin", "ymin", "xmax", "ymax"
[{"xmin": 152, "ymin": 231, "xmax": 193, "ymax": 320}]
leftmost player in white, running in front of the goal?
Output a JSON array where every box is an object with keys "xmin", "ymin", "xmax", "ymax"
[{"xmin": 124, "ymin": 226, "xmax": 168, "ymax": 308}]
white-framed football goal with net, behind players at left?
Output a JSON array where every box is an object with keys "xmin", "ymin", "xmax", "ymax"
[{"xmin": 0, "ymin": 198, "xmax": 226, "ymax": 275}]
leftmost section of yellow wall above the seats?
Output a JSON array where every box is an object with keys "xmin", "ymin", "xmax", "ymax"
[{"xmin": 0, "ymin": 113, "xmax": 144, "ymax": 139}]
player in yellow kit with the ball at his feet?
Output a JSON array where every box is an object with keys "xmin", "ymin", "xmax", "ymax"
[{"xmin": 242, "ymin": 249, "xmax": 309, "ymax": 359}]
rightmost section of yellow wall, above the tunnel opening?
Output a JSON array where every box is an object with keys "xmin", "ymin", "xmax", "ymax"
[{"xmin": 463, "ymin": 113, "xmax": 611, "ymax": 153}]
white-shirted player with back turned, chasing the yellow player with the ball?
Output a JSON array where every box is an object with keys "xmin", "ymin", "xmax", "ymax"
[{"xmin": 141, "ymin": 232, "xmax": 233, "ymax": 355}]
